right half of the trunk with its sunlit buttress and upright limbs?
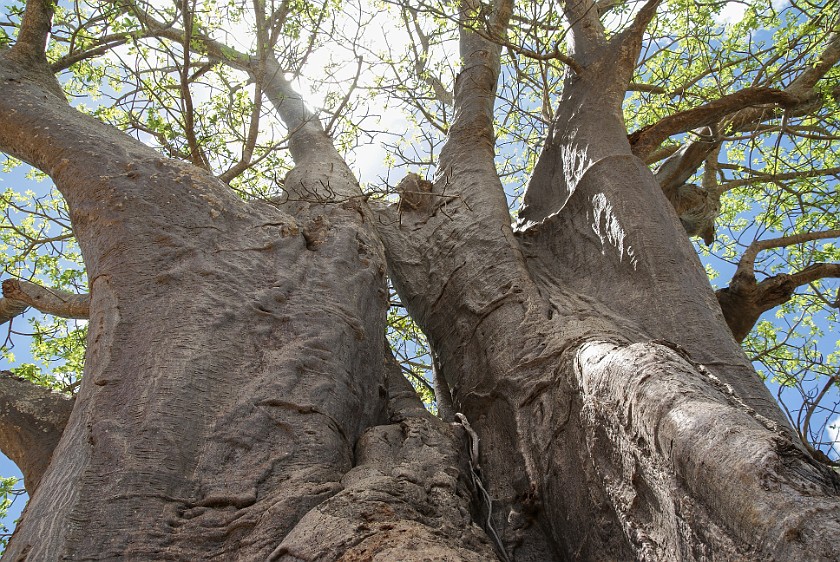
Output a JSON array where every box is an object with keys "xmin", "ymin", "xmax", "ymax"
[{"xmin": 379, "ymin": 2, "xmax": 840, "ymax": 560}]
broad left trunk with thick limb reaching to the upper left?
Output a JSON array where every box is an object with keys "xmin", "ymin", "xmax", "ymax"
[{"xmin": 0, "ymin": 50, "xmax": 493, "ymax": 560}]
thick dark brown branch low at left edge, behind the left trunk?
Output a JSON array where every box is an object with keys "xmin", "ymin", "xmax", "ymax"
[{"xmin": 0, "ymin": 371, "xmax": 74, "ymax": 496}]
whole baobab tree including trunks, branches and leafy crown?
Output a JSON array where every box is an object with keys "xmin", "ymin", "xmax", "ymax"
[{"xmin": 0, "ymin": 0, "xmax": 840, "ymax": 561}]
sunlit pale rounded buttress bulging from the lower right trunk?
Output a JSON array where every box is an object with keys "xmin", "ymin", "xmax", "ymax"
[{"xmin": 575, "ymin": 341, "xmax": 840, "ymax": 560}]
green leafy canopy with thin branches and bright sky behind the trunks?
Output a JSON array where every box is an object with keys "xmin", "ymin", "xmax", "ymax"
[{"xmin": 0, "ymin": 0, "xmax": 840, "ymax": 548}]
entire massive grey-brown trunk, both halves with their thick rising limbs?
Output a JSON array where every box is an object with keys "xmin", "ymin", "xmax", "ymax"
[{"xmin": 0, "ymin": 2, "xmax": 840, "ymax": 561}]
